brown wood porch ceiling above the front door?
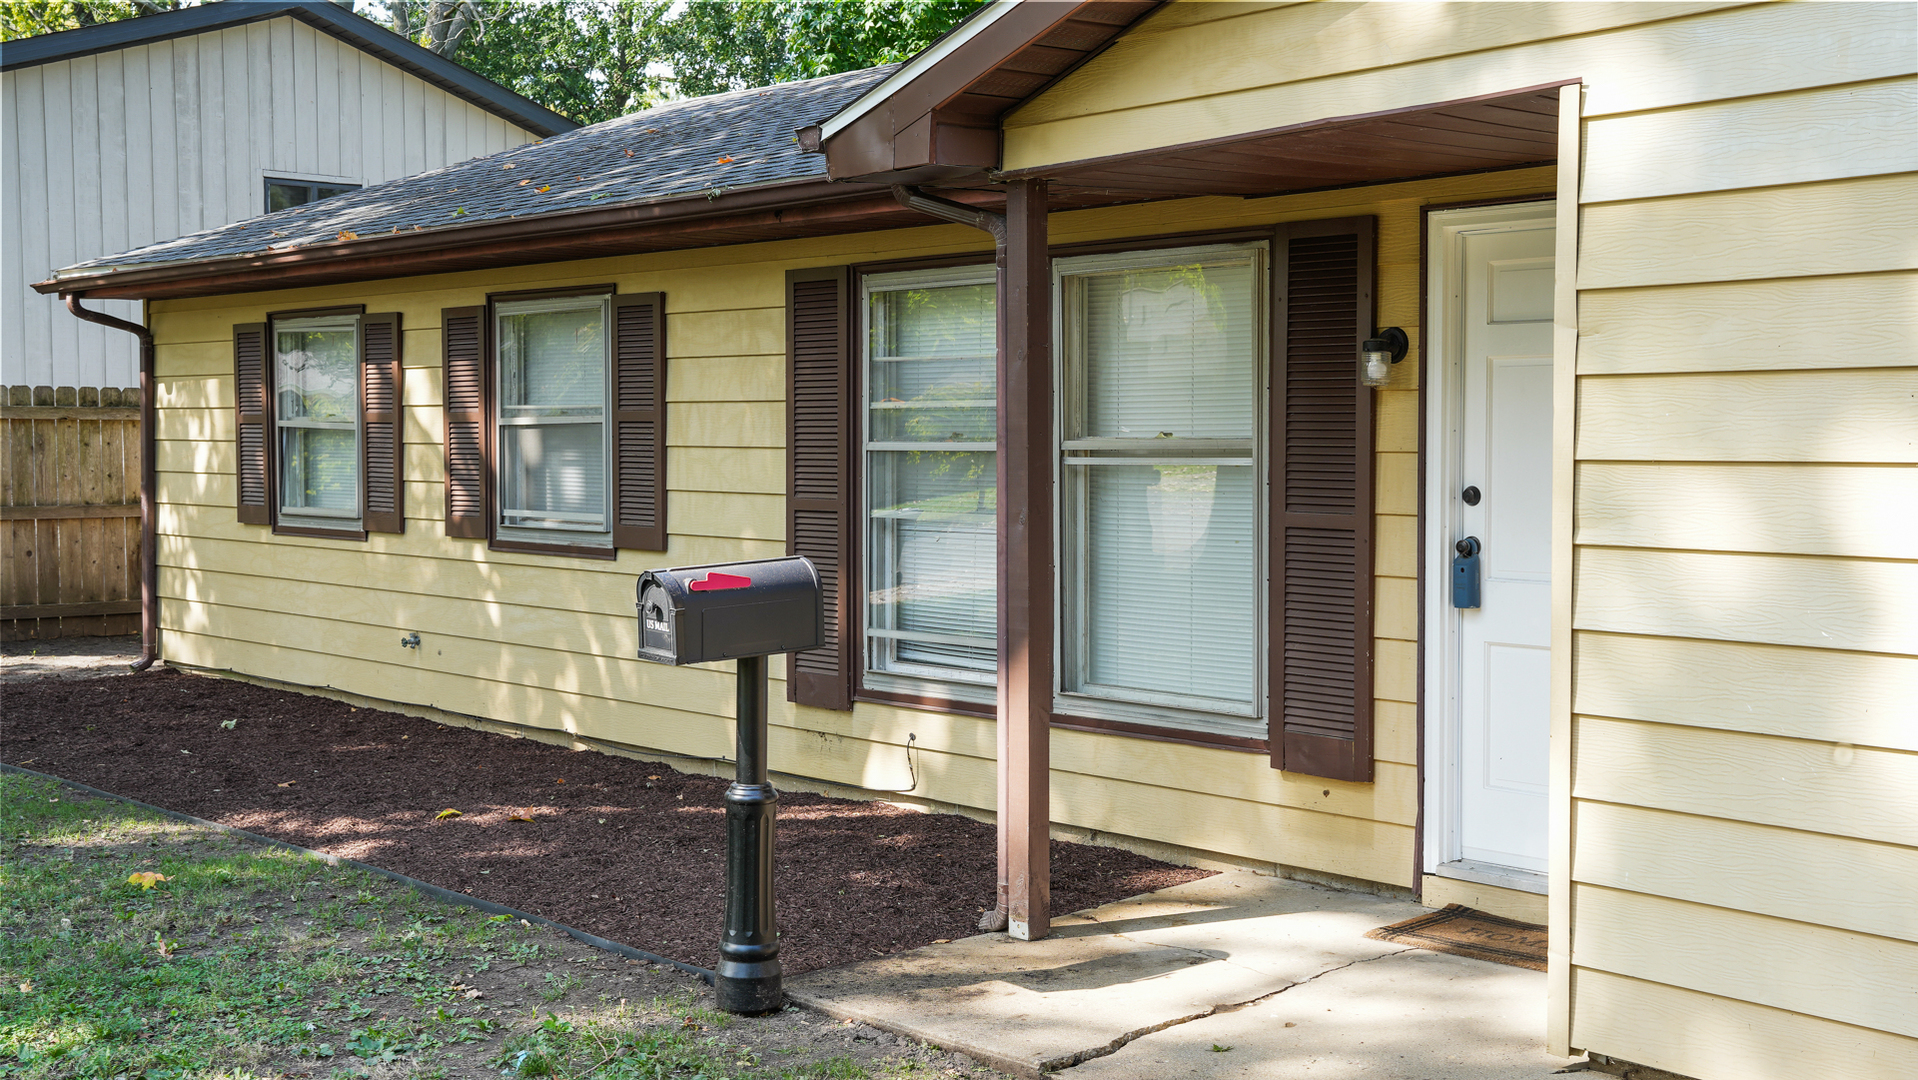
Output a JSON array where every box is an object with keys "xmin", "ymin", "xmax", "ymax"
[{"xmin": 999, "ymin": 84, "xmax": 1557, "ymax": 203}]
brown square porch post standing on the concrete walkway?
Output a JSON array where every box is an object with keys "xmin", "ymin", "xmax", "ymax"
[{"xmin": 997, "ymin": 180, "xmax": 1053, "ymax": 940}]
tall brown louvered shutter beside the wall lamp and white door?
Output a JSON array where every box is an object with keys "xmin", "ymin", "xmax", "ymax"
[{"xmin": 1268, "ymin": 217, "xmax": 1375, "ymax": 781}]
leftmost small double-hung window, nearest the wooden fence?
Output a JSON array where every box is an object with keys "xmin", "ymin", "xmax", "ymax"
[{"xmin": 272, "ymin": 315, "xmax": 361, "ymax": 529}]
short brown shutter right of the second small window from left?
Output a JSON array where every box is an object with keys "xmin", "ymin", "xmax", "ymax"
[{"xmin": 612, "ymin": 292, "xmax": 666, "ymax": 551}]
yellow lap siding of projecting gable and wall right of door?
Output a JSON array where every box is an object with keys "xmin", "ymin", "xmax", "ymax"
[{"xmin": 1005, "ymin": 2, "xmax": 1918, "ymax": 1080}]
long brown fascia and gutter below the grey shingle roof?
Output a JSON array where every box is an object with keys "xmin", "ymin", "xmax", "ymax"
[{"xmin": 33, "ymin": 178, "xmax": 900, "ymax": 299}]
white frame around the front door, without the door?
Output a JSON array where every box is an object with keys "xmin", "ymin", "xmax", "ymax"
[{"xmin": 1417, "ymin": 196, "xmax": 1559, "ymax": 894}]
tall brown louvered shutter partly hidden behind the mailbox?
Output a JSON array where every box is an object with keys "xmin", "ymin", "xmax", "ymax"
[{"xmin": 786, "ymin": 267, "xmax": 854, "ymax": 710}]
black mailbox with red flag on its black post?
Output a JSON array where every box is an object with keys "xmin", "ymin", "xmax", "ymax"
[{"xmin": 637, "ymin": 556, "xmax": 825, "ymax": 1015}]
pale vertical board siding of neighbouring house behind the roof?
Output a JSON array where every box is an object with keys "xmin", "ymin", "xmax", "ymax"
[{"xmin": 0, "ymin": 17, "xmax": 537, "ymax": 386}]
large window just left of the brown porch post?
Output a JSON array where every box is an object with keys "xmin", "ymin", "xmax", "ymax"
[{"xmin": 861, "ymin": 267, "xmax": 997, "ymax": 696}]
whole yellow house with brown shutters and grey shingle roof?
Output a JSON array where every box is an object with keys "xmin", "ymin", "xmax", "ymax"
[{"xmin": 38, "ymin": 2, "xmax": 1918, "ymax": 1080}]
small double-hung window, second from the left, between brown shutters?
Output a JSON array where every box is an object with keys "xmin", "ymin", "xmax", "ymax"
[{"xmin": 493, "ymin": 295, "xmax": 612, "ymax": 547}]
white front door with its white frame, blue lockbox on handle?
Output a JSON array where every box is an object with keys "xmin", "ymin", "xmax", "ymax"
[{"xmin": 1427, "ymin": 203, "xmax": 1554, "ymax": 888}]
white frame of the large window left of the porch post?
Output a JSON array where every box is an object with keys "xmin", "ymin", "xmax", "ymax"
[{"xmin": 854, "ymin": 263, "xmax": 999, "ymax": 704}]
